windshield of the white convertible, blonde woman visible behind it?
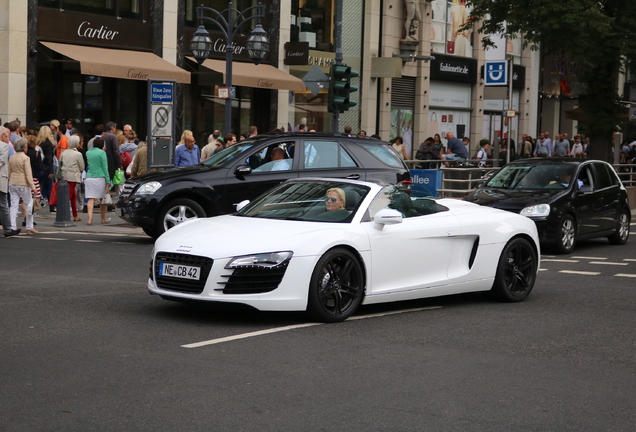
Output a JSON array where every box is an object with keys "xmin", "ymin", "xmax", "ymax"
[{"xmin": 236, "ymin": 181, "xmax": 369, "ymax": 223}]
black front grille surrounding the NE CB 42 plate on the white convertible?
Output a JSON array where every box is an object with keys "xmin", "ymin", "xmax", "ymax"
[{"xmin": 154, "ymin": 252, "xmax": 214, "ymax": 294}]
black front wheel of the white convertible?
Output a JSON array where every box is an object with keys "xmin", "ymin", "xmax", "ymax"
[{"xmin": 307, "ymin": 248, "xmax": 364, "ymax": 323}]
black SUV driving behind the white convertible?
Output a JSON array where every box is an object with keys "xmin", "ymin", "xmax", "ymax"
[{"xmin": 116, "ymin": 132, "xmax": 411, "ymax": 238}]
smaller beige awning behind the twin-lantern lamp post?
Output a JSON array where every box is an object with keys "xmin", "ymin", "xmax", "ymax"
[{"xmin": 195, "ymin": 59, "xmax": 307, "ymax": 91}]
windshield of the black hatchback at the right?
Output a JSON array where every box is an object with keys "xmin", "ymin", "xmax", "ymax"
[{"xmin": 487, "ymin": 163, "xmax": 575, "ymax": 189}]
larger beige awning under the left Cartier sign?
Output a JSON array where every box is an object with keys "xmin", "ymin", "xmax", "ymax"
[{"xmin": 41, "ymin": 42, "xmax": 190, "ymax": 84}]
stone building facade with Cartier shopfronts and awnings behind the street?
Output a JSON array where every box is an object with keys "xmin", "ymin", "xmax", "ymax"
[{"xmin": 0, "ymin": 0, "xmax": 576, "ymax": 159}]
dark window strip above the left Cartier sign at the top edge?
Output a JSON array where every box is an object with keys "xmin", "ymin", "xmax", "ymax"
[{"xmin": 38, "ymin": 0, "xmax": 149, "ymax": 20}]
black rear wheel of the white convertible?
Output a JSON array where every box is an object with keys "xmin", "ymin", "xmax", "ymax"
[{"xmin": 489, "ymin": 237, "xmax": 539, "ymax": 302}]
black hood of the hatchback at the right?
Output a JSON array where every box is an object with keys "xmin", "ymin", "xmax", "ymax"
[{"xmin": 464, "ymin": 187, "xmax": 564, "ymax": 212}]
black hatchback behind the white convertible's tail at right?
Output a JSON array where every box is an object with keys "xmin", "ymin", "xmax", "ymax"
[{"xmin": 464, "ymin": 158, "xmax": 631, "ymax": 253}]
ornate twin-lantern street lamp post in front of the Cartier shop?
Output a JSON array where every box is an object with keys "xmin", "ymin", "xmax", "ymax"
[{"xmin": 190, "ymin": 2, "xmax": 269, "ymax": 133}]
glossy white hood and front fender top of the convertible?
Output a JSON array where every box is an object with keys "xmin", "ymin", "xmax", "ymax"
[{"xmin": 155, "ymin": 215, "xmax": 368, "ymax": 259}]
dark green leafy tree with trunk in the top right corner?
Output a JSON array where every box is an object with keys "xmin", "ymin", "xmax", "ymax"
[{"xmin": 467, "ymin": 0, "xmax": 636, "ymax": 161}]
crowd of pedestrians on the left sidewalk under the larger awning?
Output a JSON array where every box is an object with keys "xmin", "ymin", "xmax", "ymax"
[{"xmin": 0, "ymin": 119, "xmax": 148, "ymax": 237}]
